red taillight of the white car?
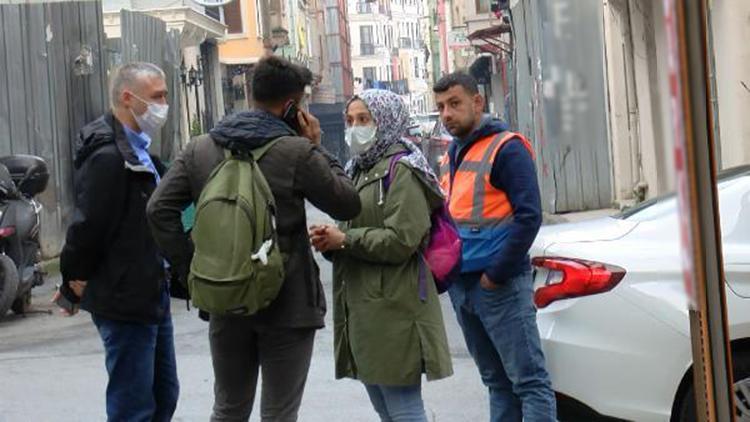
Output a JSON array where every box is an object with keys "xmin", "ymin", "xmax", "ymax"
[{"xmin": 531, "ymin": 257, "xmax": 625, "ymax": 308}]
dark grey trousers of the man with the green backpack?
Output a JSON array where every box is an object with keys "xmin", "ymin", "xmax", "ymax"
[{"xmin": 209, "ymin": 315, "xmax": 316, "ymax": 422}]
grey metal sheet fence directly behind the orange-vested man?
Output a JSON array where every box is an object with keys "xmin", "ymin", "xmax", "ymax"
[{"xmin": 512, "ymin": 0, "xmax": 613, "ymax": 212}]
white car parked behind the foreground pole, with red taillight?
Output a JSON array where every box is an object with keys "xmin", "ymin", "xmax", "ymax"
[{"xmin": 531, "ymin": 166, "xmax": 750, "ymax": 422}]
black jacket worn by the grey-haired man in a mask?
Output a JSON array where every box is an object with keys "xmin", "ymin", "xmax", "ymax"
[{"xmin": 60, "ymin": 113, "xmax": 165, "ymax": 323}]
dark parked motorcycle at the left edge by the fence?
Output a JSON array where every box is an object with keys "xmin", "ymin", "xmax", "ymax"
[{"xmin": 0, "ymin": 155, "xmax": 49, "ymax": 318}]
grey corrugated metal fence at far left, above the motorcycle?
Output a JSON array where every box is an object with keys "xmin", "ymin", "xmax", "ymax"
[{"xmin": 0, "ymin": 1, "xmax": 109, "ymax": 257}]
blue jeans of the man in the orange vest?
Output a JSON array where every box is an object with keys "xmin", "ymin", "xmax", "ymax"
[{"xmin": 449, "ymin": 271, "xmax": 557, "ymax": 422}]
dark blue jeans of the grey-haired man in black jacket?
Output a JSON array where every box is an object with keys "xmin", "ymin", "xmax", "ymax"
[{"xmin": 91, "ymin": 288, "xmax": 180, "ymax": 422}]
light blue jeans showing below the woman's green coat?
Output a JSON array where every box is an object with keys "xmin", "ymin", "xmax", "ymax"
[{"xmin": 365, "ymin": 384, "xmax": 427, "ymax": 422}]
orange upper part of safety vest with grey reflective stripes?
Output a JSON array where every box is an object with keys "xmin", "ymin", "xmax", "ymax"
[{"xmin": 440, "ymin": 132, "xmax": 534, "ymax": 227}]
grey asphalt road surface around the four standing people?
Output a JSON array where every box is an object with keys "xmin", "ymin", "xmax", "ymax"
[{"xmin": 0, "ymin": 205, "xmax": 488, "ymax": 422}]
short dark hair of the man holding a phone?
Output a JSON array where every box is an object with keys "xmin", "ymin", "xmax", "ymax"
[{"xmin": 252, "ymin": 56, "xmax": 313, "ymax": 104}]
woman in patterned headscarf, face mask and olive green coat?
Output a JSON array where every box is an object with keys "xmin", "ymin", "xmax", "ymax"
[{"xmin": 310, "ymin": 90, "xmax": 453, "ymax": 422}]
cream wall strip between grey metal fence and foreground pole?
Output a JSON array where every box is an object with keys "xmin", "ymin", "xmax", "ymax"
[{"xmin": 604, "ymin": 0, "xmax": 674, "ymax": 205}]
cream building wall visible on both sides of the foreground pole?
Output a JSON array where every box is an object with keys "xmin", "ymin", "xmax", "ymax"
[{"xmin": 604, "ymin": 0, "xmax": 750, "ymax": 203}]
